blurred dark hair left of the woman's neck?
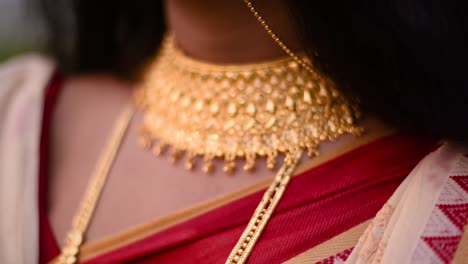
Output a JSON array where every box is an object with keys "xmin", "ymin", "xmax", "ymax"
[{"xmin": 39, "ymin": 0, "xmax": 166, "ymax": 79}]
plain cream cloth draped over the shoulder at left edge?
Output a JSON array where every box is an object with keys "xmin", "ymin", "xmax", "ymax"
[{"xmin": 0, "ymin": 55, "xmax": 54, "ymax": 264}]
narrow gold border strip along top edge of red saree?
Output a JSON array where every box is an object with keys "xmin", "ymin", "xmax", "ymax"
[{"xmin": 75, "ymin": 130, "xmax": 394, "ymax": 261}]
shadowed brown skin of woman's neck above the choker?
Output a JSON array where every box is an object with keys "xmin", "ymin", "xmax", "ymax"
[{"xmin": 164, "ymin": 0, "xmax": 302, "ymax": 64}]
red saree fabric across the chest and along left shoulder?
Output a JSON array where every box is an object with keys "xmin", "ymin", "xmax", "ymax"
[{"xmin": 39, "ymin": 76, "xmax": 435, "ymax": 263}]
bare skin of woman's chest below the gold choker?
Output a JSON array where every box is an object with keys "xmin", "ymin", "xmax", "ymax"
[{"xmin": 46, "ymin": 96, "xmax": 274, "ymax": 246}]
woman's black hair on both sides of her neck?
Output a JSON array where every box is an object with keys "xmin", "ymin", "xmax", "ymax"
[{"xmin": 41, "ymin": 0, "xmax": 468, "ymax": 141}]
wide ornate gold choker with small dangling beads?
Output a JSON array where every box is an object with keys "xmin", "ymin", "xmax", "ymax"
[{"xmin": 137, "ymin": 36, "xmax": 361, "ymax": 172}]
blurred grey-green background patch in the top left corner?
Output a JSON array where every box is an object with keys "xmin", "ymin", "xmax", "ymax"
[{"xmin": 0, "ymin": 0, "xmax": 44, "ymax": 63}]
